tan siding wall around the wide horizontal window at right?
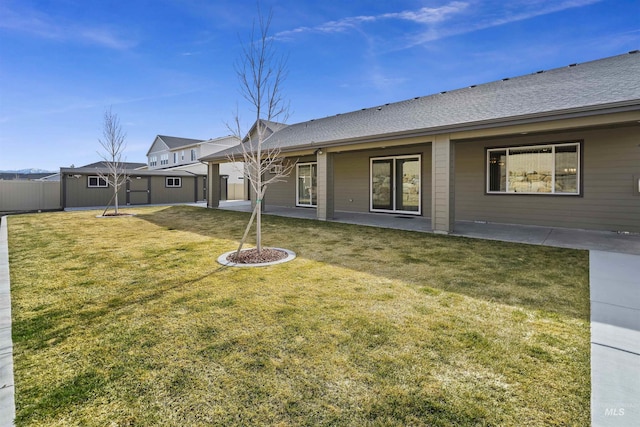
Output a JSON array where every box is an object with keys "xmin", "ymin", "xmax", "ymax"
[{"xmin": 455, "ymin": 126, "xmax": 640, "ymax": 232}]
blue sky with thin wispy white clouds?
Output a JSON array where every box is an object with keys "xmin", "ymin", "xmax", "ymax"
[{"xmin": 0, "ymin": 0, "xmax": 640, "ymax": 171}]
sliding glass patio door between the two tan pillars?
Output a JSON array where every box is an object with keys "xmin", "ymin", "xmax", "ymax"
[{"xmin": 370, "ymin": 155, "xmax": 422, "ymax": 214}]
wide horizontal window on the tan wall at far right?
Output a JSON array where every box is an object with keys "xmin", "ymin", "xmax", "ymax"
[{"xmin": 487, "ymin": 142, "xmax": 580, "ymax": 195}]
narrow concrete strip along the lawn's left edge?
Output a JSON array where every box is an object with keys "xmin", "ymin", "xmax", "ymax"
[{"xmin": 0, "ymin": 216, "xmax": 16, "ymax": 427}]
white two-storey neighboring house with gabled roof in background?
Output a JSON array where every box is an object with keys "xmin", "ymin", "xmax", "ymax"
[{"xmin": 147, "ymin": 135, "xmax": 247, "ymax": 200}]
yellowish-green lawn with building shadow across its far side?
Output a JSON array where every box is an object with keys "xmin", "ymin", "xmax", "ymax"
[{"xmin": 9, "ymin": 207, "xmax": 590, "ymax": 426}]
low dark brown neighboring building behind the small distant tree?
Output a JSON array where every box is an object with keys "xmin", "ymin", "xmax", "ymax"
[{"xmin": 60, "ymin": 163, "xmax": 207, "ymax": 209}]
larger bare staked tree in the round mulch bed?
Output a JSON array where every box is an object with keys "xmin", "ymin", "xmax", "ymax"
[{"xmin": 227, "ymin": 7, "xmax": 295, "ymax": 257}]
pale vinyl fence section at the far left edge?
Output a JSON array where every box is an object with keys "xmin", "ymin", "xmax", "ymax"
[{"xmin": 0, "ymin": 181, "xmax": 62, "ymax": 212}]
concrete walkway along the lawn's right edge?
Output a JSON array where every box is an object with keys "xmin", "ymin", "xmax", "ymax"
[{"xmin": 589, "ymin": 251, "xmax": 640, "ymax": 427}]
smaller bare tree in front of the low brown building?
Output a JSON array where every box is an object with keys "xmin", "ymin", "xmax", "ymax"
[{"xmin": 98, "ymin": 108, "xmax": 128, "ymax": 215}]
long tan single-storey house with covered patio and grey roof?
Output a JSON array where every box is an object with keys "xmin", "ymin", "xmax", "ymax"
[{"xmin": 201, "ymin": 51, "xmax": 640, "ymax": 233}]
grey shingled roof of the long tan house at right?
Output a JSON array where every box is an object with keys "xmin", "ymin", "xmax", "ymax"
[{"xmin": 201, "ymin": 51, "xmax": 640, "ymax": 160}]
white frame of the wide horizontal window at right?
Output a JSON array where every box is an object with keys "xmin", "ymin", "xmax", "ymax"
[{"xmin": 485, "ymin": 141, "xmax": 582, "ymax": 196}]
